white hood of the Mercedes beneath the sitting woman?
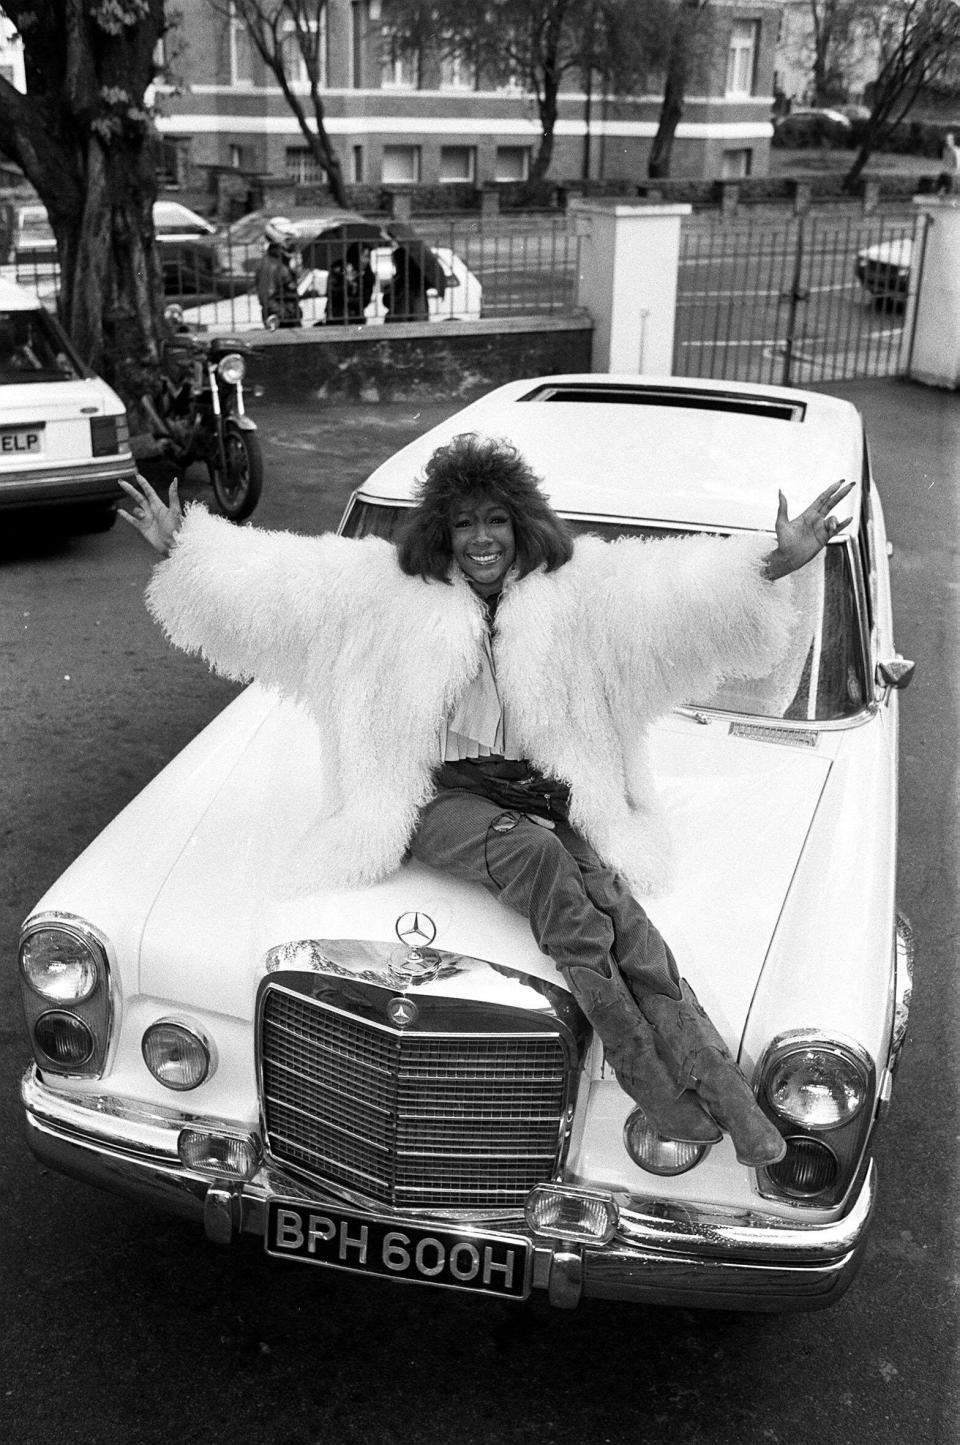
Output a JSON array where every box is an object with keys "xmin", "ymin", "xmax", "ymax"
[{"xmin": 140, "ymin": 704, "xmax": 830, "ymax": 1043}]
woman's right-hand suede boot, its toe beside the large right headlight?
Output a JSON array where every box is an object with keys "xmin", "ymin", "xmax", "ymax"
[{"xmin": 639, "ymin": 978, "xmax": 787, "ymax": 1169}]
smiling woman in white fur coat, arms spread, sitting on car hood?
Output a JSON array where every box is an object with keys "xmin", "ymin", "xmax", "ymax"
[{"xmin": 121, "ymin": 435, "xmax": 849, "ymax": 1168}]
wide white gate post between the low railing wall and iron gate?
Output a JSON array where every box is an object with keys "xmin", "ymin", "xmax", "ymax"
[{"xmin": 567, "ymin": 199, "xmax": 693, "ymax": 376}]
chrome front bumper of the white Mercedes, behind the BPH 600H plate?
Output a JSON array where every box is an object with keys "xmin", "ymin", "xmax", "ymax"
[{"xmin": 22, "ymin": 1065, "xmax": 876, "ymax": 1312}]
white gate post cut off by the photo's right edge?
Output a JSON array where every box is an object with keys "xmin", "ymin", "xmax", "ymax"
[{"xmin": 908, "ymin": 195, "xmax": 960, "ymax": 387}]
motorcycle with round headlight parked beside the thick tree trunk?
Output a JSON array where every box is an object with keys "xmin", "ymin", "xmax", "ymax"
[{"xmin": 143, "ymin": 312, "xmax": 263, "ymax": 522}]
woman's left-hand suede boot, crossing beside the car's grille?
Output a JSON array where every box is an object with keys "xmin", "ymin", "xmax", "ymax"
[{"xmin": 562, "ymin": 967, "xmax": 723, "ymax": 1144}]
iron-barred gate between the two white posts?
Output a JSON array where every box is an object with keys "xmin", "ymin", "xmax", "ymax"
[{"xmin": 674, "ymin": 212, "xmax": 927, "ymax": 386}]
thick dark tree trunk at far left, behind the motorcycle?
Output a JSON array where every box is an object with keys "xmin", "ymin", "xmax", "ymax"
[{"xmin": 0, "ymin": 0, "xmax": 165, "ymax": 405}]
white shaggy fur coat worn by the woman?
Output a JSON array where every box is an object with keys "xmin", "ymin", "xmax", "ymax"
[{"xmin": 147, "ymin": 506, "xmax": 795, "ymax": 893}]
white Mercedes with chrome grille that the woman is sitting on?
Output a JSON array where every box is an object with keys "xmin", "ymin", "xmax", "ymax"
[{"xmin": 20, "ymin": 376, "xmax": 912, "ymax": 1311}]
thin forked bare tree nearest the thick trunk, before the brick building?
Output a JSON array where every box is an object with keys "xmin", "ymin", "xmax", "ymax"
[{"xmin": 219, "ymin": 0, "xmax": 347, "ymax": 205}]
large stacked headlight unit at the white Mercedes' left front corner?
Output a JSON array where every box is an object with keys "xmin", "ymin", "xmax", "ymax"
[{"xmin": 20, "ymin": 913, "xmax": 113, "ymax": 1078}]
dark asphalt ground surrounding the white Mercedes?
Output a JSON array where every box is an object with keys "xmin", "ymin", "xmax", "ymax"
[{"xmin": 0, "ymin": 381, "xmax": 960, "ymax": 1445}]
